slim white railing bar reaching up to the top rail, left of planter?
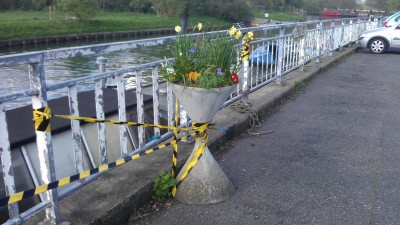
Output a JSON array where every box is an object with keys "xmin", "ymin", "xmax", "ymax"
[{"xmin": 94, "ymin": 57, "xmax": 108, "ymax": 165}]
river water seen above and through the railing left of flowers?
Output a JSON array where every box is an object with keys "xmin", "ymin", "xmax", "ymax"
[{"xmin": 0, "ymin": 37, "xmax": 171, "ymax": 105}]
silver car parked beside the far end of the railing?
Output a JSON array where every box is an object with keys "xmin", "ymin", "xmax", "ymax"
[{"xmin": 358, "ymin": 23, "xmax": 400, "ymax": 54}]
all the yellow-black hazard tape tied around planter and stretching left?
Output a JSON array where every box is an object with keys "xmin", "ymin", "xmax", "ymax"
[{"xmin": 32, "ymin": 105, "xmax": 212, "ymax": 200}]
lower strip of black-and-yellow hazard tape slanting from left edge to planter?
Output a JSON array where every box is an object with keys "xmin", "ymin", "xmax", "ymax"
[{"xmin": 0, "ymin": 133, "xmax": 198, "ymax": 207}]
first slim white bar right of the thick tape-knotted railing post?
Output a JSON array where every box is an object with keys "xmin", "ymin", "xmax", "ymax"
[{"xmin": 68, "ymin": 86, "xmax": 84, "ymax": 173}]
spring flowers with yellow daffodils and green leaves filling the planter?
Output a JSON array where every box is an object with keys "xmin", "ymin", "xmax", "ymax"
[{"xmin": 161, "ymin": 23, "xmax": 253, "ymax": 89}]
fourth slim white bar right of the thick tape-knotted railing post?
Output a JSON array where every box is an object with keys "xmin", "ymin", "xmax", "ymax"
[{"xmin": 136, "ymin": 70, "xmax": 146, "ymax": 148}]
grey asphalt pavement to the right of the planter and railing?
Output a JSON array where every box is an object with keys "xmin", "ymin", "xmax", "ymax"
[{"xmin": 135, "ymin": 51, "xmax": 400, "ymax": 225}]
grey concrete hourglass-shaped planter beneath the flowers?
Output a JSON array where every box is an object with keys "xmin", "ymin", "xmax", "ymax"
[{"xmin": 172, "ymin": 84, "xmax": 236, "ymax": 204}]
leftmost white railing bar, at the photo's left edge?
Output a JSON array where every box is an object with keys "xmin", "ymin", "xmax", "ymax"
[{"xmin": 0, "ymin": 103, "xmax": 19, "ymax": 220}]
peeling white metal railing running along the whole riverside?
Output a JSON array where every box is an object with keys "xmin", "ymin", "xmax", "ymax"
[{"xmin": 0, "ymin": 19, "xmax": 379, "ymax": 224}]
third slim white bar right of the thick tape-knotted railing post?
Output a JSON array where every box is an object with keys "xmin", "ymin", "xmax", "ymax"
[{"xmin": 117, "ymin": 75, "xmax": 128, "ymax": 156}]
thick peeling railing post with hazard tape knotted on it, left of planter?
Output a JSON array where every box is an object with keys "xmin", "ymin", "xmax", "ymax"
[{"xmin": 28, "ymin": 59, "xmax": 60, "ymax": 224}]
